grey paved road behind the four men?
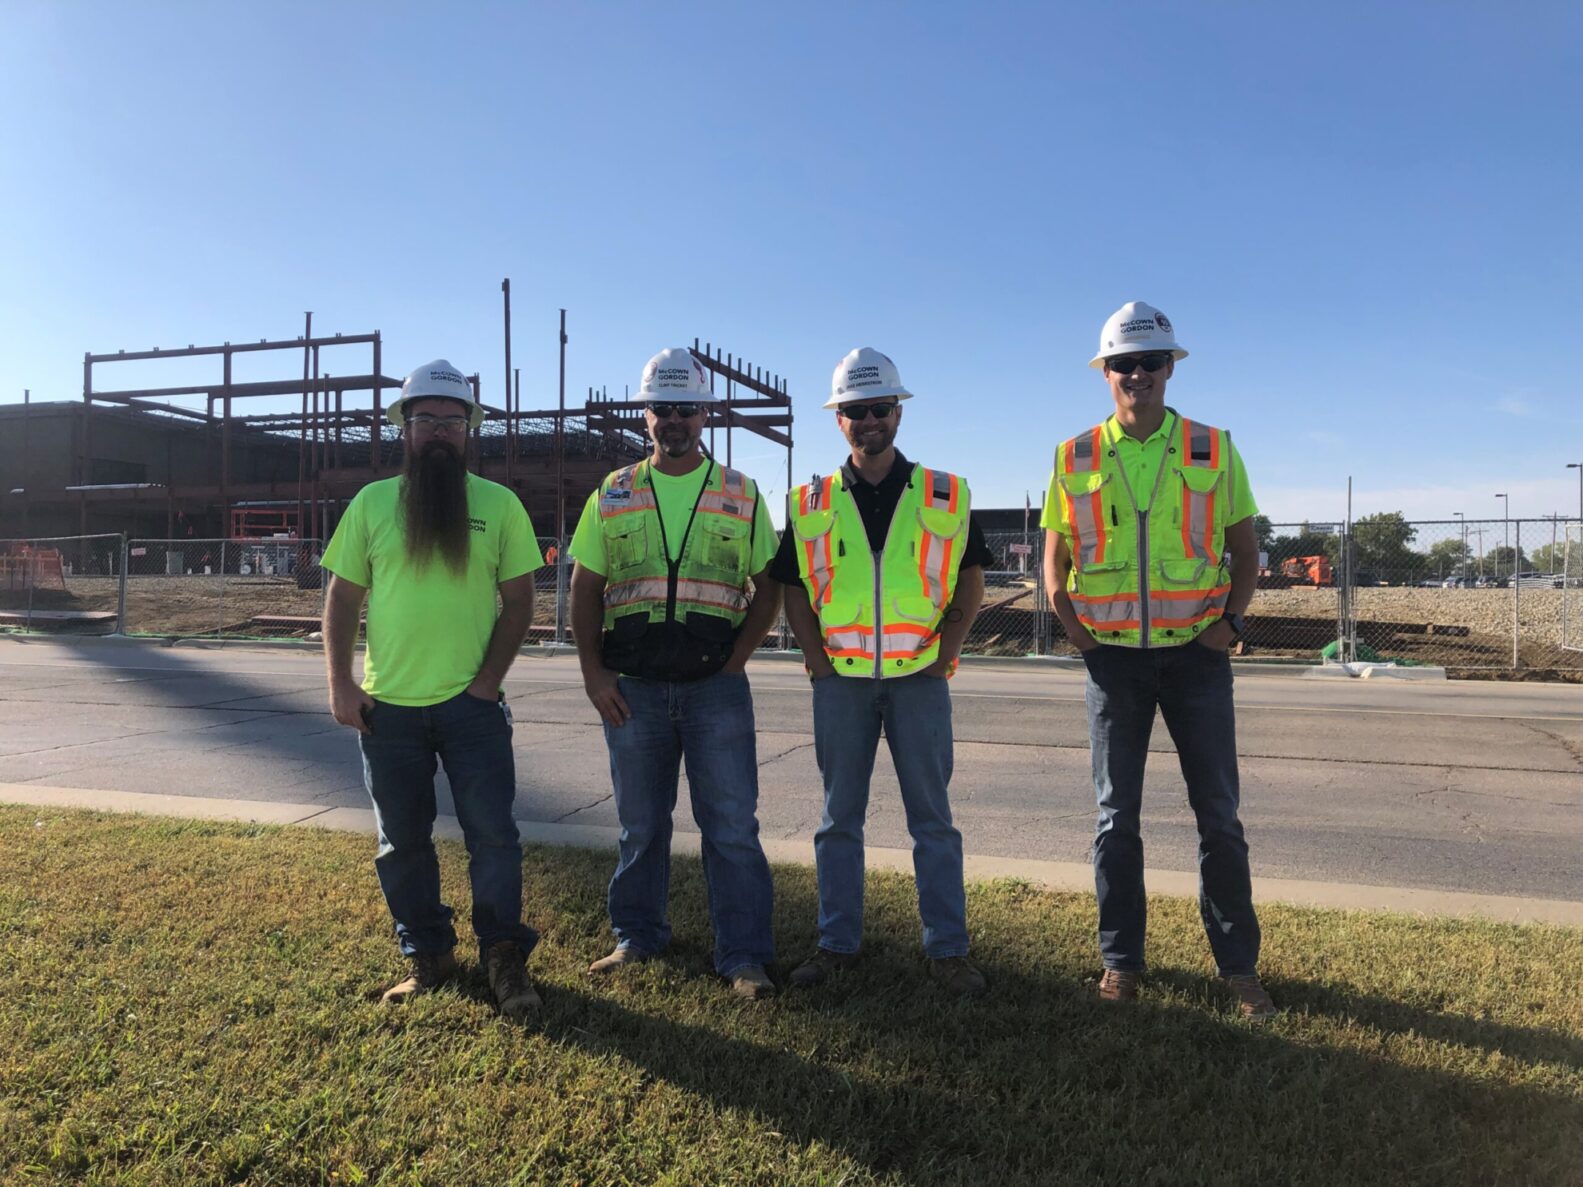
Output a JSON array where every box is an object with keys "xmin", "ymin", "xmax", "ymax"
[{"xmin": 0, "ymin": 636, "xmax": 1583, "ymax": 902}]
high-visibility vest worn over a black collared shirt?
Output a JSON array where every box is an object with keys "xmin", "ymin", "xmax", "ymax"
[{"xmin": 787, "ymin": 465, "xmax": 972, "ymax": 679}]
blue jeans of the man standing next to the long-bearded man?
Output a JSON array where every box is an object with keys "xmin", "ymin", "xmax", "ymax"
[{"xmin": 605, "ymin": 673, "xmax": 776, "ymax": 977}]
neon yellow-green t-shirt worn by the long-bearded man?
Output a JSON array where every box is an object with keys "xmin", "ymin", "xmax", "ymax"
[{"xmin": 323, "ymin": 473, "xmax": 545, "ymax": 704}]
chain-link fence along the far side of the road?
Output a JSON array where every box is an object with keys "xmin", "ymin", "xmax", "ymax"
[{"xmin": 0, "ymin": 514, "xmax": 1583, "ymax": 673}]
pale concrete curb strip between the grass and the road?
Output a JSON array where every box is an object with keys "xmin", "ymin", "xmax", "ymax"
[{"xmin": 0, "ymin": 783, "xmax": 1583, "ymax": 927}]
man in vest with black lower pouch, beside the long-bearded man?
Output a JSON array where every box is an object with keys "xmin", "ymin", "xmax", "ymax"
[{"xmin": 571, "ymin": 347, "xmax": 780, "ymax": 999}]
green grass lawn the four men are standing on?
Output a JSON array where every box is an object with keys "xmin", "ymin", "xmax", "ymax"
[{"xmin": 0, "ymin": 807, "xmax": 1583, "ymax": 1187}]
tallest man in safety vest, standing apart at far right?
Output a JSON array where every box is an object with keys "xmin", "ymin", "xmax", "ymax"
[{"xmin": 1043, "ymin": 301, "xmax": 1274, "ymax": 1018}]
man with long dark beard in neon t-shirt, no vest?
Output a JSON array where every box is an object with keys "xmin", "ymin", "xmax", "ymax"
[{"xmin": 323, "ymin": 359, "xmax": 543, "ymax": 1021}]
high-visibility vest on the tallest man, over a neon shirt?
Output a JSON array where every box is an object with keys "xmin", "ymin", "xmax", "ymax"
[{"xmin": 1056, "ymin": 413, "xmax": 1233, "ymax": 647}]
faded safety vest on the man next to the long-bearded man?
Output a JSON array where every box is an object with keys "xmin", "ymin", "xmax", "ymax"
[{"xmin": 598, "ymin": 459, "xmax": 758, "ymax": 630}]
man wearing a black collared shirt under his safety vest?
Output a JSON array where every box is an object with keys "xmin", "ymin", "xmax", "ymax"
[{"xmin": 769, "ymin": 347, "xmax": 991, "ymax": 995}]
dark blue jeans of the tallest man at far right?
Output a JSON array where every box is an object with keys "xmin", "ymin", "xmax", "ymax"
[{"xmin": 1083, "ymin": 643, "xmax": 1258, "ymax": 977}]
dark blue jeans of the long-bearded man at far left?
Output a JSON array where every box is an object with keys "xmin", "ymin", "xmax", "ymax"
[{"xmin": 359, "ymin": 692, "xmax": 538, "ymax": 961}]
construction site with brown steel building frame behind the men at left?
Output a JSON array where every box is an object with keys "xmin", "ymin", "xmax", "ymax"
[{"xmin": 0, "ymin": 289, "xmax": 792, "ymax": 636}]
